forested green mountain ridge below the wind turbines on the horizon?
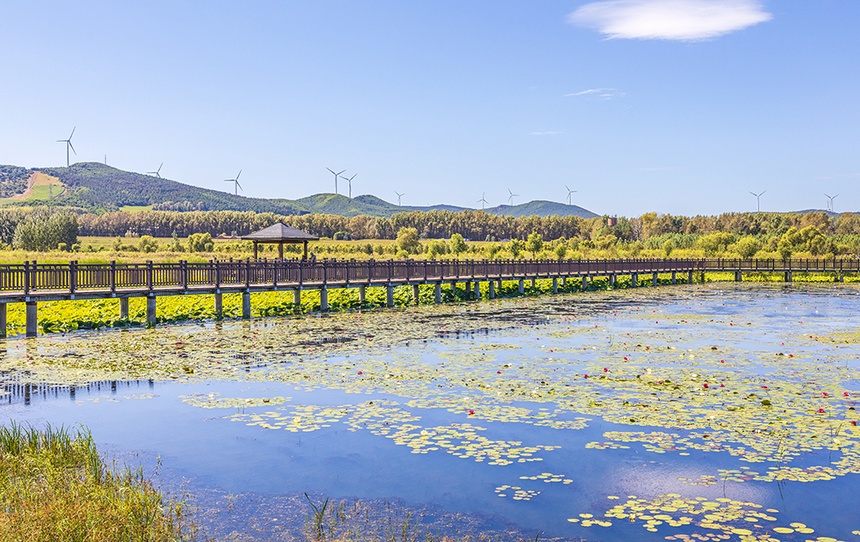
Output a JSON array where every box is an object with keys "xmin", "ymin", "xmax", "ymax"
[{"xmin": 0, "ymin": 162, "xmax": 598, "ymax": 218}]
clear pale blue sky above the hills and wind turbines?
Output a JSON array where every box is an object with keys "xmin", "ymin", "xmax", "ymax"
[{"xmin": 0, "ymin": 0, "xmax": 860, "ymax": 216}]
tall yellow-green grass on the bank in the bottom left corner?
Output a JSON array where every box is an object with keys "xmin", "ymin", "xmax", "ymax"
[{"xmin": 0, "ymin": 422, "xmax": 189, "ymax": 542}]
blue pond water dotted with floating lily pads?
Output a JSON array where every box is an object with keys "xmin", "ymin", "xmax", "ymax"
[{"xmin": 0, "ymin": 284, "xmax": 860, "ymax": 541}]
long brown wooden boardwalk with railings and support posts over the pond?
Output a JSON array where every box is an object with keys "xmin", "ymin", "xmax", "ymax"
[{"xmin": 0, "ymin": 259, "xmax": 860, "ymax": 336}]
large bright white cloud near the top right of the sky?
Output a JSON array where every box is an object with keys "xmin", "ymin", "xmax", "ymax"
[{"xmin": 568, "ymin": 0, "xmax": 771, "ymax": 41}]
